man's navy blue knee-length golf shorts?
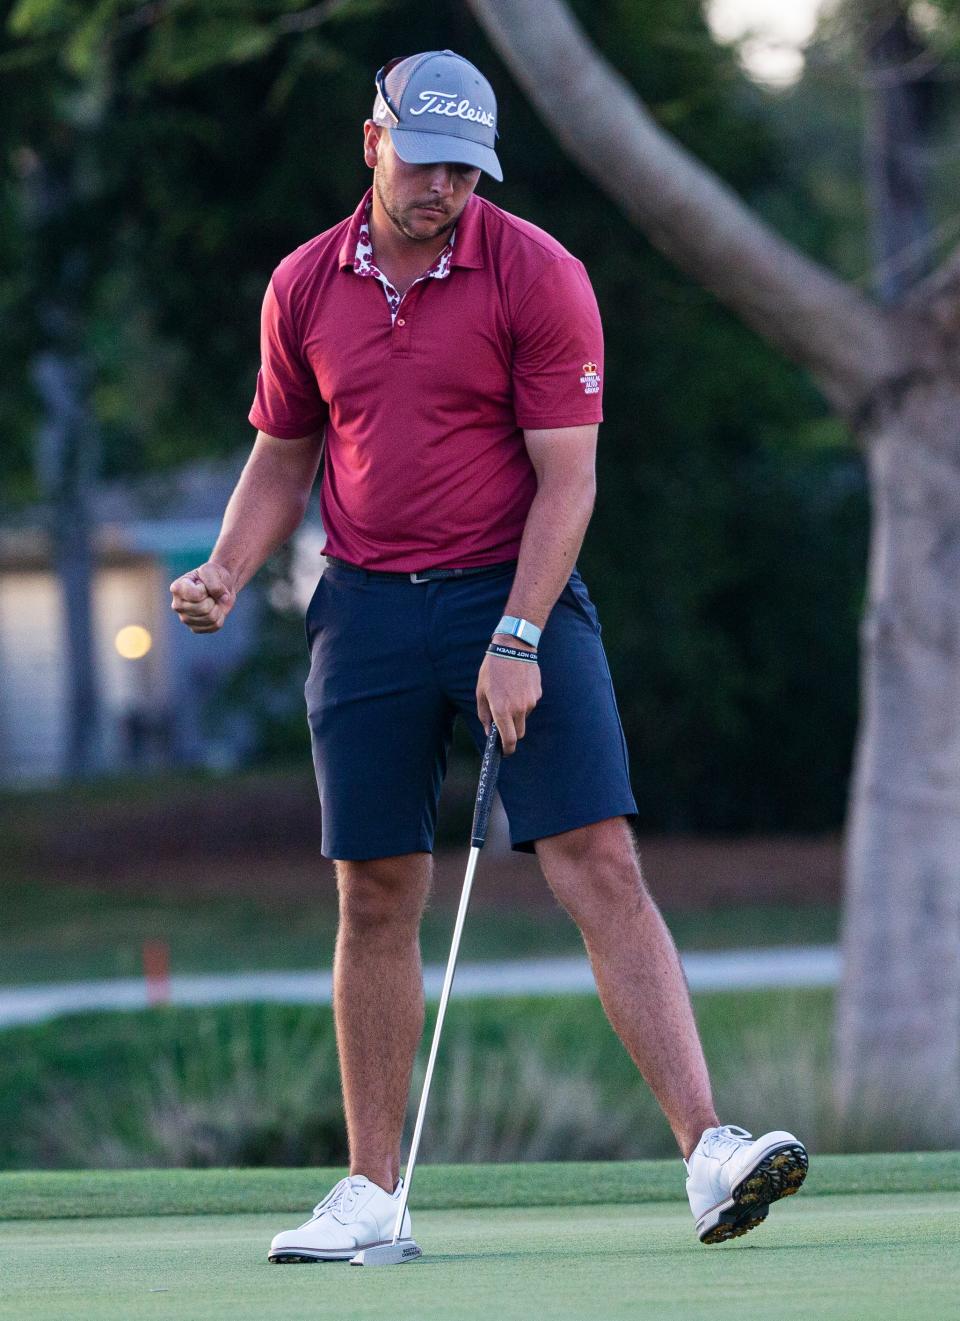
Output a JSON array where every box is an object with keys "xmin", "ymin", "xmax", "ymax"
[{"xmin": 305, "ymin": 564, "xmax": 636, "ymax": 860}]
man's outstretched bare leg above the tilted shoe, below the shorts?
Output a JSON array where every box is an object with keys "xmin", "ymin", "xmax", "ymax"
[{"xmin": 536, "ymin": 816, "xmax": 717, "ymax": 1157}]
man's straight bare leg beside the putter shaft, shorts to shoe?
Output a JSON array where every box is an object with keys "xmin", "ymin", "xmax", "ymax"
[{"xmin": 333, "ymin": 853, "xmax": 432, "ymax": 1193}]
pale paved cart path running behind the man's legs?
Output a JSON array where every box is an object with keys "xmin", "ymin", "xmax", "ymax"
[{"xmin": 0, "ymin": 945, "xmax": 840, "ymax": 1028}]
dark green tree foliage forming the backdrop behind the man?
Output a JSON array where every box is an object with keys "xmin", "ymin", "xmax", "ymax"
[{"xmin": 0, "ymin": 0, "xmax": 866, "ymax": 828}]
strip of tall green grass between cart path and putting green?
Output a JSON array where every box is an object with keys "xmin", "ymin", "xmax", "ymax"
[{"xmin": 0, "ymin": 991, "xmax": 855, "ymax": 1168}]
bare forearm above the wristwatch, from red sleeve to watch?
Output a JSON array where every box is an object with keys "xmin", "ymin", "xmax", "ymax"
[{"xmin": 504, "ymin": 480, "xmax": 596, "ymax": 639}]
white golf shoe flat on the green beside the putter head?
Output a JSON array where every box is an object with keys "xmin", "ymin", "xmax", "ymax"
[{"xmin": 267, "ymin": 1174, "xmax": 411, "ymax": 1263}]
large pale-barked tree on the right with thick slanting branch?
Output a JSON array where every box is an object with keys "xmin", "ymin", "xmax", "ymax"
[{"xmin": 470, "ymin": 0, "xmax": 960, "ymax": 1143}]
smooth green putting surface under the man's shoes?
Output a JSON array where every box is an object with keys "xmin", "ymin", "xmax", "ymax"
[{"xmin": 0, "ymin": 1153, "xmax": 960, "ymax": 1321}]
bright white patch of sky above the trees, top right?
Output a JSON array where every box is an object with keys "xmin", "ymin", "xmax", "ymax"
[{"xmin": 706, "ymin": 0, "xmax": 828, "ymax": 87}]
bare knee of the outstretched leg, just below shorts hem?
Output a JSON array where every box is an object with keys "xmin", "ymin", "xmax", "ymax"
[{"xmin": 536, "ymin": 816, "xmax": 648, "ymax": 919}]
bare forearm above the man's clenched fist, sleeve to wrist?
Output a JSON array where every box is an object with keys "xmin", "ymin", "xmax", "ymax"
[{"xmin": 210, "ymin": 439, "xmax": 320, "ymax": 592}]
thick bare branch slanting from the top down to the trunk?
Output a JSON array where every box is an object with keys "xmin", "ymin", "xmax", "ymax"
[{"xmin": 469, "ymin": 0, "xmax": 905, "ymax": 413}]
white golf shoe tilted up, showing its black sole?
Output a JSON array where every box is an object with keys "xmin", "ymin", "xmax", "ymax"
[{"xmin": 684, "ymin": 1124, "xmax": 808, "ymax": 1243}]
